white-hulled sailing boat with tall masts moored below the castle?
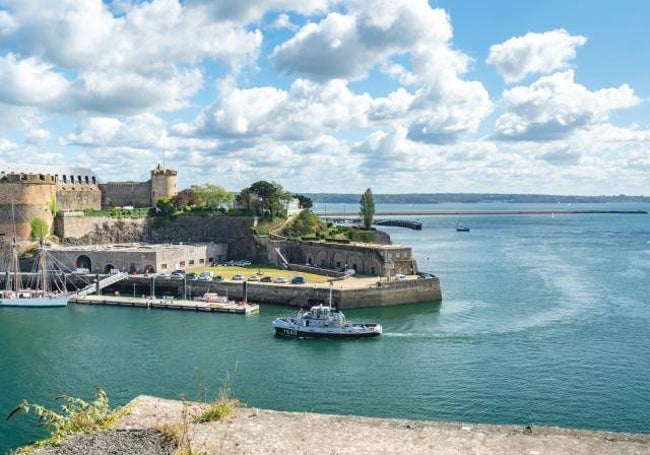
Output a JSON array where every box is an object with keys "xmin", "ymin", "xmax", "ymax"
[{"xmin": 0, "ymin": 206, "xmax": 70, "ymax": 307}]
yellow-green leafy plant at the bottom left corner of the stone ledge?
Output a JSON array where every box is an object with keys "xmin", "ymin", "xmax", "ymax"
[{"xmin": 7, "ymin": 387, "xmax": 127, "ymax": 453}]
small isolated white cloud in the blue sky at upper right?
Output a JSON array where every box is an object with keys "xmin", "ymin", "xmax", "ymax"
[{"xmin": 487, "ymin": 29, "xmax": 587, "ymax": 83}]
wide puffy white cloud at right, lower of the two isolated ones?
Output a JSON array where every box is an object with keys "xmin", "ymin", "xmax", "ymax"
[{"xmin": 495, "ymin": 70, "xmax": 640, "ymax": 140}]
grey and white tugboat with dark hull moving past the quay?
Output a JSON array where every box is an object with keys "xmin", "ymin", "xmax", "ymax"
[{"xmin": 273, "ymin": 287, "xmax": 382, "ymax": 338}]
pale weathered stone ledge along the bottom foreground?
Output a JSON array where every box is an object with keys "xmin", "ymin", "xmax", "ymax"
[{"xmin": 39, "ymin": 396, "xmax": 650, "ymax": 455}]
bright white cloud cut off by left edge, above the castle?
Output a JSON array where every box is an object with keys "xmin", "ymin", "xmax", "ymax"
[{"xmin": 0, "ymin": 53, "xmax": 69, "ymax": 105}]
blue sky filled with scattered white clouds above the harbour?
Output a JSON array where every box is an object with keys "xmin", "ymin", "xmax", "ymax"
[{"xmin": 0, "ymin": 0, "xmax": 650, "ymax": 196}]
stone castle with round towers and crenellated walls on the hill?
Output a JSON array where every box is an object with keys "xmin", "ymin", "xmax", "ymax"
[{"xmin": 0, "ymin": 164, "xmax": 177, "ymax": 240}]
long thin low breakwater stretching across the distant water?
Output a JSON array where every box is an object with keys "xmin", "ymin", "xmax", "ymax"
[{"xmin": 315, "ymin": 210, "xmax": 648, "ymax": 218}]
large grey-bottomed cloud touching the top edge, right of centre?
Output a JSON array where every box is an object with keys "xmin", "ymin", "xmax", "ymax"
[{"xmin": 272, "ymin": 0, "xmax": 451, "ymax": 80}]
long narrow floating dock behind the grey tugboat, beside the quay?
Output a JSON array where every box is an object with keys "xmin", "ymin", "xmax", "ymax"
[{"xmin": 70, "ymin": 295, "xmax": 260, "ymax": 315}]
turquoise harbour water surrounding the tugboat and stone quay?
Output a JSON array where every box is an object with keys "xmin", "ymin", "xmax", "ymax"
[{"xmin": 0, "ymin": 204, "xmax": 650, "ymax": 451}]
